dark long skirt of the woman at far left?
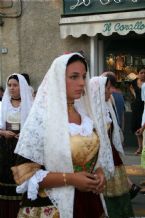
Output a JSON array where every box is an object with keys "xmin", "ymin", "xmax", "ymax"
[{"xmin": 0, "ymin": 137, "xmax": 22, "ymax": 218}]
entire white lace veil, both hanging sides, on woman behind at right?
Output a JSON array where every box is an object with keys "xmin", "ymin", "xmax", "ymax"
[{"xmin": 89, "ymin": 76, "xmax": 123, "ymax": 177}]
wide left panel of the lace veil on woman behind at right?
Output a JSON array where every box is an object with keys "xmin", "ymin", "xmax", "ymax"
[{"xmin": 89, "ymin": 77, "xmax": 114, "ymax": 177}]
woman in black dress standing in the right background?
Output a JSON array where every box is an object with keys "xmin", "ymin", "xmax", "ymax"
[{"xmin": 130, "ymin": 68, "xmax": 145, "ymax": 155}]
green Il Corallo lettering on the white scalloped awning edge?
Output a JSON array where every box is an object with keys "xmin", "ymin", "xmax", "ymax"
[{"xmin": 102, "ymin": 20, "xmax": 145, "ymax": 35}]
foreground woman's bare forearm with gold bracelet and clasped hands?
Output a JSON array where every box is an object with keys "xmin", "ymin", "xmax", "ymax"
[{"xmin": 36, "ymin": 168, "xmax": 105, "ymax": 193}]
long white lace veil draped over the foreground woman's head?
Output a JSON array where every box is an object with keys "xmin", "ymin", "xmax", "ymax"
[{"xmin": 15, "ymin": 53, "xmax": 94, "ymax": 218}]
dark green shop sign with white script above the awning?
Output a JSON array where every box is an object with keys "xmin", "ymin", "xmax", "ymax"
[{"xmin": 63, "ymin": 0, "xmax": 145, "ymax": 16}]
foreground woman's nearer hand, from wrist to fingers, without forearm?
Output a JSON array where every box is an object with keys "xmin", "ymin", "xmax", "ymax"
[{"xmin": 70, "ymin": 172, "xmax": 101, "ymax": 193}]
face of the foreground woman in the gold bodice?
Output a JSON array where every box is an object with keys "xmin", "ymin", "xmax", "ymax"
[{"xmin": 66, "ymin": 61, "xmax": 86, "ymax": 102}]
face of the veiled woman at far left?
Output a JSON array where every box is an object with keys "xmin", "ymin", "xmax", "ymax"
[{"xmin": 8, "ymin": 79, "xmax": 20, "ymax": 98}]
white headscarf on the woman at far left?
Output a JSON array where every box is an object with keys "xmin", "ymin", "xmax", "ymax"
[{"xmin": 0, "ymin": 73, "xmax": 33, "ymax": 129}]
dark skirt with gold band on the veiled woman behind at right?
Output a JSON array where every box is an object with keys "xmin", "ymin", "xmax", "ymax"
[{"xmin": 104, "ymin": 141, "xmax": 134, "ymax": 218}]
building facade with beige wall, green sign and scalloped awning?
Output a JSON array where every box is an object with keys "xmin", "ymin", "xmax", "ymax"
[{"xmin": 0, "ymin": 0, "xmax": 145, "ymax": 89}]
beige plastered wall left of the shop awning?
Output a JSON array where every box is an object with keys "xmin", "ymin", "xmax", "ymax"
[{"xmin": 0, "ymin": 0, "xmax": 89, "ymax": 90}]
